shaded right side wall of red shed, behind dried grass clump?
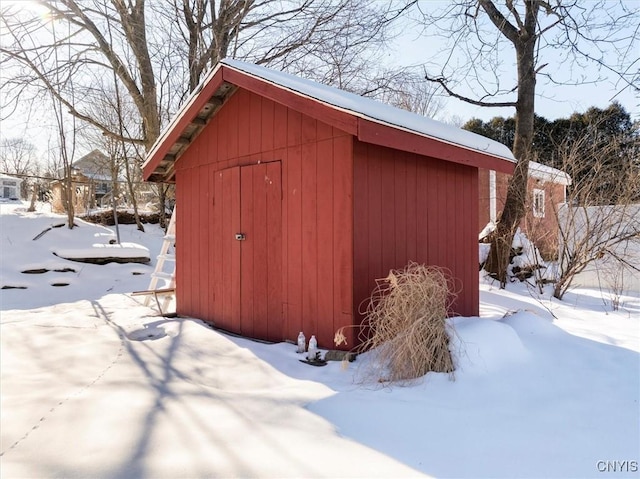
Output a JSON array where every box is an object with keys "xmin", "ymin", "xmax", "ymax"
[{"xmin": 354, "ymin": 141, "xmax": 479, "ymax": 322}]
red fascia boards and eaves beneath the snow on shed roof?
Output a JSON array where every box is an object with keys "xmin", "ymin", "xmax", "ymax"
[{"xmin": 143, "ymin": 59, "xmax": 515, "ymax": 182}]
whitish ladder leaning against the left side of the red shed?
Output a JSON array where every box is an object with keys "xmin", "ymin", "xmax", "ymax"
[{"xmin": 132, "ymin": 206, "xmax": 176, "ymax": 316}]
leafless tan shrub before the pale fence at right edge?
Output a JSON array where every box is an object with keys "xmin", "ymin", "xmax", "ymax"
[{"xmin": 553, "ymin": 126, "xmax": 640, "ymax": 299}]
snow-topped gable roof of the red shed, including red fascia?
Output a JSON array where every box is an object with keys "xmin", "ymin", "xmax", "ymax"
[{"xmin": 143, "ymin": 59, "xmax": 515, "ymax": 181}]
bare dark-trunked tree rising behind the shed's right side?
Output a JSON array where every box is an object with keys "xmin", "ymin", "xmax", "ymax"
[{"xmin": 413, "ymin": 0, "xmax": 640, "ymax": 286}]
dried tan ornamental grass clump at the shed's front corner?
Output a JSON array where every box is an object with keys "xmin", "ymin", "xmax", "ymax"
[{"xmin": 334, "ymin": 262, "xmax": 455, "ymax": 382}]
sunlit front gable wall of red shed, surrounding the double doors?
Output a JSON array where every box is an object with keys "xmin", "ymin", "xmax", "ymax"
[{"xmin": 176, "ymin": 89, "xmax": 353, "ymax": 348}]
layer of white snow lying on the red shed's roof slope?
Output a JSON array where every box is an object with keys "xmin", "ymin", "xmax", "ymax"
[{"xmin": 222, "ymin": 58, "xmax": 515, "ymax": 161}]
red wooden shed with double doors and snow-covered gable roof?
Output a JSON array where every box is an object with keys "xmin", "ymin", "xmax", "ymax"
[{"xmin": 143, "ymin": 60, "xmax": 514, "ymax": 349}]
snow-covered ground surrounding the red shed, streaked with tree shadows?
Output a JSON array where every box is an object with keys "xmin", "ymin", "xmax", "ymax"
[{"xmin": 0, "ymin": 204, "xmax": 640, "ymax": 478}]
